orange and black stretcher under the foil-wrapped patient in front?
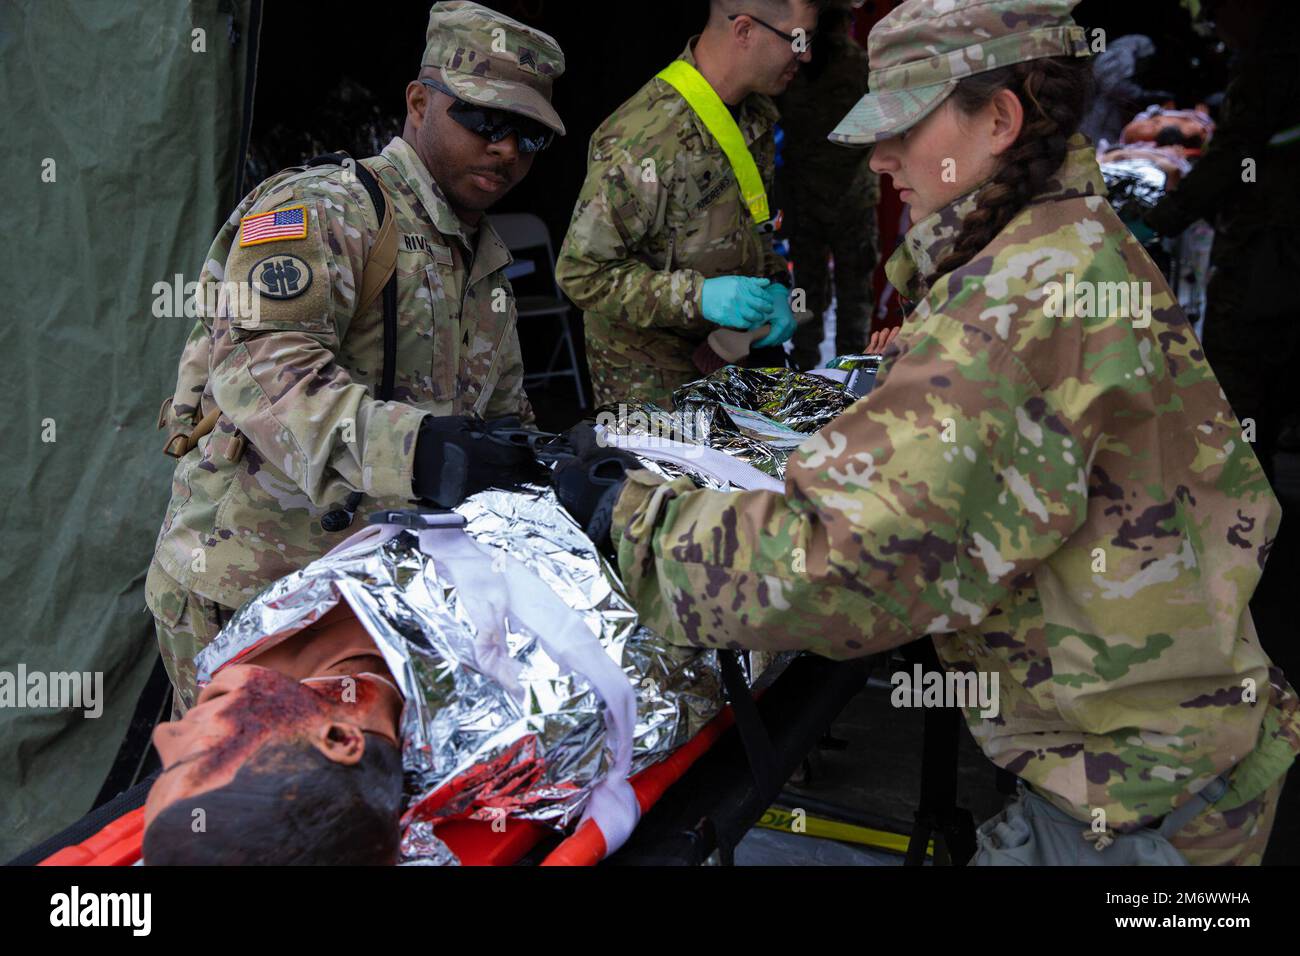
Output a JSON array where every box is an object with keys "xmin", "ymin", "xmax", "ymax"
[{"xmin": 10, "ymin": 657, "xmax": 875, "ymax": 866}]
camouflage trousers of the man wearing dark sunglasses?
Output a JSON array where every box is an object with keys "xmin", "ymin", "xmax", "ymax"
[{"xmin": 144, "ymin": 561, "xmax": 235, "ymax": 719}]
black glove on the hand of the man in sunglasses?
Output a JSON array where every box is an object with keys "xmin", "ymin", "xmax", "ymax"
[{"xmin": 411, "ymin": 415, "xmax": 545, "ymax": 507}]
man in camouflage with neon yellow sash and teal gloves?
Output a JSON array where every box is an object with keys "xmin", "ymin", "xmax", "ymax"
[{"xmin": 556, "ymin": 0, "xmax": 816, "ymax": 406}]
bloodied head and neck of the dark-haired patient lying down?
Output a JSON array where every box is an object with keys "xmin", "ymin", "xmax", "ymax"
[{"xmin": 144, "ymin": 602, "xmax": 403, "ymax": 865}]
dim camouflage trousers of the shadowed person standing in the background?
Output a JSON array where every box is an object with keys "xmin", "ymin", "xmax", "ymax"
[{"xmin": 790, "ymin": 206, "xmax": 876, "ymax": 369}]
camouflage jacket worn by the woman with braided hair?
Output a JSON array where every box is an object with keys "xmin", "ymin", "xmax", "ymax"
[{"xmin": 615, "ymin": 138, "xmax": 1300, "ymax": 829}]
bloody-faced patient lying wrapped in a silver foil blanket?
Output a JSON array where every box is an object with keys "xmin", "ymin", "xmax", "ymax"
[{"xmin": 144, "ymin": 473, "xmax": 769, "ymax": 865}]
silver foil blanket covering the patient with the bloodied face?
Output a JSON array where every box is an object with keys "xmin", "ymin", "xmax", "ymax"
[{"xmin": 196, "ymin": 488, "xmax": 722, "ymax": 862}]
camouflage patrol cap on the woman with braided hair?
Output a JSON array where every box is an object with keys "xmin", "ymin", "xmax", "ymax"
[{"xmin": 828, "ymin": 0, "xmax": 1088, "ymax": 146}]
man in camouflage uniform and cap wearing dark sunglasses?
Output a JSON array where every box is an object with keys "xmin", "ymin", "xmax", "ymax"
[{"xmin": 146, "ymin": 3, "xmax": 564, "ymax": 709}]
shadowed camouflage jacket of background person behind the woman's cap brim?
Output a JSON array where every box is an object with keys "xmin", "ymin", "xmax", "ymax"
[{"xmin": 776, "ymin": 33, "xmax": 880, "ymax": 217}]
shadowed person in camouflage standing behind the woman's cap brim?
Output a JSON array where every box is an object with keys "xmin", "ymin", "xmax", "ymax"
[{"xmin": 776, "ymin": 0, "xmax": 880, "ymax": 368}]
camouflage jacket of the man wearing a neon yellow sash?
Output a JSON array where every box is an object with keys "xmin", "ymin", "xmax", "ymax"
[{"xmin": 555, "ymin": 39, "xmax": 789, "ymax": 371}]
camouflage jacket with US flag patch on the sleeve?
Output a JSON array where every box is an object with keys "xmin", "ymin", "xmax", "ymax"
[{"xmin": 156, "ymin": 138, "xmax": 532, "ymax": 607}]
